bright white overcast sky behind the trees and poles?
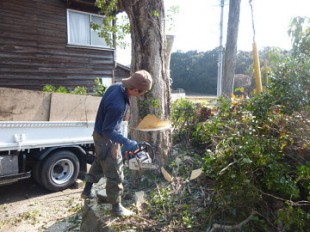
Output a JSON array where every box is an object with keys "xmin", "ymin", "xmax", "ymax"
[{"xmin": 117, "ymin": 0, "xmax": 310, "ymax": 65}]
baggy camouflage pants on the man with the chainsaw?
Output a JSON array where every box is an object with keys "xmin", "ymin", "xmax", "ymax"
[{"xmin": 86, "ymin": 132, "xmax": 124, "ymax": 204}]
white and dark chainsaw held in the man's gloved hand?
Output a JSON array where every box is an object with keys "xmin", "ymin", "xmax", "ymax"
[{"xmin": 124, "ymin": 142, "xmax": 160, "ymax": 170}]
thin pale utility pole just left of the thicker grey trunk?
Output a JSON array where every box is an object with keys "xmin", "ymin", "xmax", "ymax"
[{"xmin": 217, "ymin": 0, "xmax": 224, "ymax": 97}]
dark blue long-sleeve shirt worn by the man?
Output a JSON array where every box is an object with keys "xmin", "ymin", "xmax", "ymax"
[{"xmin": 94, "ymin": 84, "xmax": 129, "ymax": 144}]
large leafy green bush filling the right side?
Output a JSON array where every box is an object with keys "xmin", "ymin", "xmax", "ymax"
[{"xmin": 172, "ymin": 38, "xmax": 310, "ymax": 231}]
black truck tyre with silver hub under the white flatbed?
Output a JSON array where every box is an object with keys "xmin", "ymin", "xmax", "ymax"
[{"xmin": 41, "ymin": 150, "xmax": 80, "ymax": 191}]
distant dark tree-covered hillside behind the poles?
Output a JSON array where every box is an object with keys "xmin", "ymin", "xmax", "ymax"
[{"xmin": 170, "ymin": 47, "xmax": 290, "ymax": 95}]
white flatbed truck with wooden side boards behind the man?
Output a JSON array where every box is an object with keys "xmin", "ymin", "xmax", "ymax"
[{"xmin": 0, "ymin": 88, "xmax": 127, "ymax": 191}]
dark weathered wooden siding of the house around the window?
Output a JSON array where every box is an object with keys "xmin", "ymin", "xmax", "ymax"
[{"xmin": 0, "ymin": 0, "xmax": 115, "ymax": 91}]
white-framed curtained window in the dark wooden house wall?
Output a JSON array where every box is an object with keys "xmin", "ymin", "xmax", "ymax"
[{"xmin": 67, "ymin": 10, "xmax": 109, "ymax": 48}]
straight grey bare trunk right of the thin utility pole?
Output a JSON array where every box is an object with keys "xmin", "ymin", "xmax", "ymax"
[{"xmin": 223, "ymin": 0, "xmax": 241, "ymax": 98}]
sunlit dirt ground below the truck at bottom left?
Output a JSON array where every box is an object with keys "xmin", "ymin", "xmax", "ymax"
[{"xmin": 0, "ymin": 178, "xmax": 84, "ymax": 232}]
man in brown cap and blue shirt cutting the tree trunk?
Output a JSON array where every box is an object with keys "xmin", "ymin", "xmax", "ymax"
[{"xmin": 81, "ymin": 70, "xmax": 153, "ymax": 216}]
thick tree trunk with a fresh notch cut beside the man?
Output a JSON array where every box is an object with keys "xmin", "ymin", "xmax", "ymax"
[{"xmin": 121, "ymin": 0, "xmax": 172, "ymax": 163}]
